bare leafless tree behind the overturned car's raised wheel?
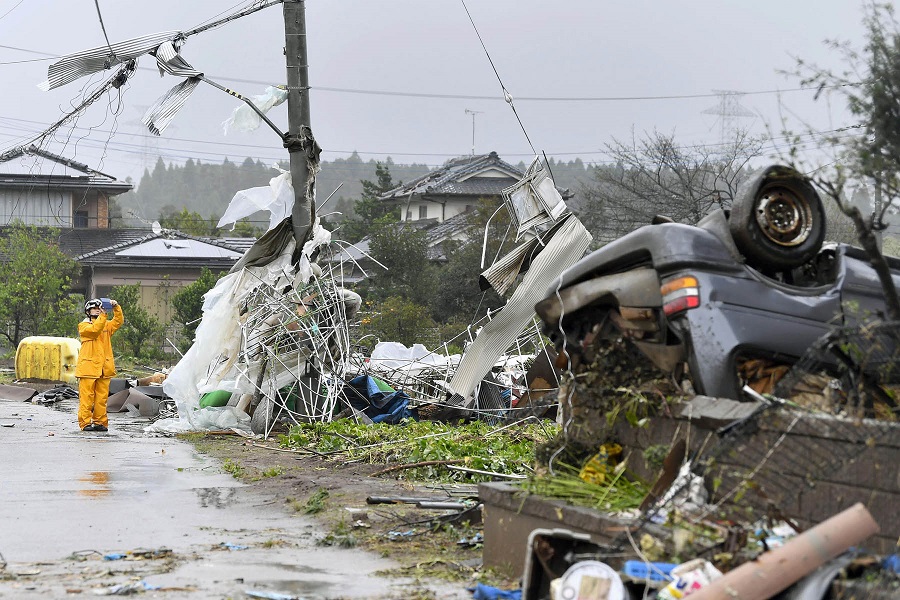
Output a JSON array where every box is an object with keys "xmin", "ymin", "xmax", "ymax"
[{"xmin": 573, "ymin": 131, "xmax": 762, "ymax": 242}]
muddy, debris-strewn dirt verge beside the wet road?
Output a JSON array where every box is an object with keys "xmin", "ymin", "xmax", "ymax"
[{"xmin": 180, "ymin": 433, "xmax": 506, "ymax": 589}]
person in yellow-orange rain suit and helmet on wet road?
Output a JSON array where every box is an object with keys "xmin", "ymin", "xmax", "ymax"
[{"xmin": 75, "ymin": 298, "xmax": 125, "ymax": 431}]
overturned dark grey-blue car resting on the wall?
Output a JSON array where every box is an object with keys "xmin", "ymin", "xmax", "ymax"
[{"xmin": 535, "ymin": 166, "xmax": 900, "ymax": 399}]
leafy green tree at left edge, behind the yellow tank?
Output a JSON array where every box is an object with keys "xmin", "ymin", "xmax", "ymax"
[{"xmin": 0, "ymin": 223, "xmax": 81, "ymax": 347}]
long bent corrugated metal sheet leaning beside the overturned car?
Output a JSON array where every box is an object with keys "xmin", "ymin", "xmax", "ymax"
[{"xmin": 450, "ymin": 215, "xmax": 591, "ymax": 399}]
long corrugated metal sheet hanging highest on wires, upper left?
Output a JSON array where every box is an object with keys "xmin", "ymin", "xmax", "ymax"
[{"xmin": 38, "ymin": 31, "xmax": 180, "ymax": 91}]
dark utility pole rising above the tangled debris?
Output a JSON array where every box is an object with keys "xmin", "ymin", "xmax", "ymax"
[{"xmin": 284, "ymin": 0, "xmax": 321, "ymax": 256}]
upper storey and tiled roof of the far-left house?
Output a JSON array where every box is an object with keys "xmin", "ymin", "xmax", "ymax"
[{"xmin": 0, "ymin": 145, "xmax": 132, "ymax": 229}]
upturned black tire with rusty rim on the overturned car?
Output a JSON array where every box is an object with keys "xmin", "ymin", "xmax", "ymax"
[{"xmin": 728, "ymin": 165, "xmax": 825, "ymax": 270}]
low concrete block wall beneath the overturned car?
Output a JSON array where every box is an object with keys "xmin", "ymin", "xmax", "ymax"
[{"xmin": 615, "ymin": 408, "xmax": 900, "ymax": 553}]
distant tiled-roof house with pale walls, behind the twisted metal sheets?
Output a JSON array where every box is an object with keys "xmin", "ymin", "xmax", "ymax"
[{"xmin": 380, "ymin": 152, "xmax": 522, "ymax": 223}]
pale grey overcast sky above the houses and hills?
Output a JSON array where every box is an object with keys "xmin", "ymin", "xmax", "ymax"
[{"xmin": 0, "ymin": 0, "xmax": 862, "ymax": 180}]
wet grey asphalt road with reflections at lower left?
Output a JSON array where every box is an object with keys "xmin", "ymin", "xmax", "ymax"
[{"xmin": 0, "ymin": 399, "xmax": 462, "ymax": 599}]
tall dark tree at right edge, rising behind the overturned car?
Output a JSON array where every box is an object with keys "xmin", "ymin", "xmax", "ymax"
[{"xmin": 782, "ymin": 2, "xmax": 900, "ymax": 321}]
